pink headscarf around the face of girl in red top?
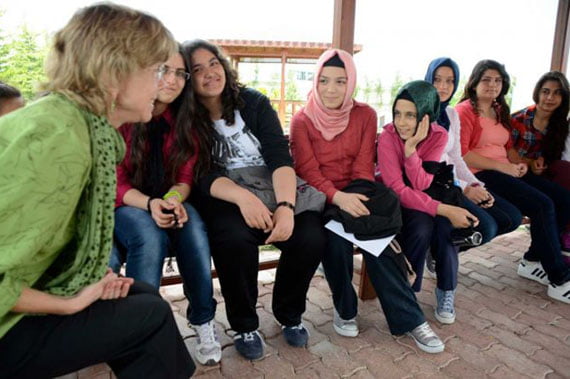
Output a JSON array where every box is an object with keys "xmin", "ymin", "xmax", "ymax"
[{"xmin": 303, "ymin": 49, "xmax": 356, "ymax": 141}]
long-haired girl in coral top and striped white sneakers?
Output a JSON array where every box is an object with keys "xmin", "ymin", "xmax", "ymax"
[{"xmin": 455, "ymin": 60, "xmax": 570, "ymax": 303}]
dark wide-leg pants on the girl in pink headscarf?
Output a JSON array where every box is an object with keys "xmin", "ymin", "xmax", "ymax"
[{"xmin": 323, "ymin": 230, "xmax": 425, "ymax": 335}]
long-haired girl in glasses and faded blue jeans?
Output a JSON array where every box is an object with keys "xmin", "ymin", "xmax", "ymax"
[{"xmin": 110, "ymin": 46, "xmax": 222, "ymax": 365}]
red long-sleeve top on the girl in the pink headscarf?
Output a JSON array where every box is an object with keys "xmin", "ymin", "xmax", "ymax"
[{"xmin": 290, "ymin": 101, "xmax": 377, "ymax": 203}]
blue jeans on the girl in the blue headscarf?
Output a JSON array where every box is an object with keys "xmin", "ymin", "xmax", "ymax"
[{"xmin": 463, "ymin": 193, "xmax": 522, "ymax": 243}]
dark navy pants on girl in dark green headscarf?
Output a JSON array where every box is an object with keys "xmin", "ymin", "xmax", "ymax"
[{"xmin": 398, "ymin": 208, "xmax": 459, "ymax": 292}]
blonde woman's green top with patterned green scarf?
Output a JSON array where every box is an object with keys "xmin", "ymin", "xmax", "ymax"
[{"xmin": 0, "ymin": 94, "xmax": 124, "ymax": 338}]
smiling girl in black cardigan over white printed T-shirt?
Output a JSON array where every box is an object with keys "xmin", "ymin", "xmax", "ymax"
[{"xmin": 183, "ymin": 40, "xmax": 325, "ymax": 359}]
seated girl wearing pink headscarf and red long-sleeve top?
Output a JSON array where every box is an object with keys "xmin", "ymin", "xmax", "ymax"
[{"xmin": 290, "ymin": 49, "xmax": 444, "ymax": 353}]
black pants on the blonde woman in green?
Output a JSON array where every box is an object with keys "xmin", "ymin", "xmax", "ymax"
[{"xmin": 0, "ymin": 282, "xmax": 195, "ymax": 378}]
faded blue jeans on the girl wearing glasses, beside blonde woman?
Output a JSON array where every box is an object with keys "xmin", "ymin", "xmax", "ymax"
[{"xmin": 109, "ymin": 203, "xmax": 216, "ymax": 325}]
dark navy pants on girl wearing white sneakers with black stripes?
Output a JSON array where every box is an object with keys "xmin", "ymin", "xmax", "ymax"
[{"xmin": 476, "ymin": 170, "xmax": 570, "ymax": 284}]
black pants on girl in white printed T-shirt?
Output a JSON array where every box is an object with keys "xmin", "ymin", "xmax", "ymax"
[{"xmin": 201, "ymin": 198, "xmax": 326, "ymax": 333}]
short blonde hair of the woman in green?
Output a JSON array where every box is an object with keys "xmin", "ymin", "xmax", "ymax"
[{"xmin": 43, "ymin": 3, "xmax": 178, "ymax": 115}]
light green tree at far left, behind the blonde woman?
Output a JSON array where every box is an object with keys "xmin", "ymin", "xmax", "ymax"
[{"xmin": 0, "ymin": 25, "xmax": 47, "ymax": 100}]
